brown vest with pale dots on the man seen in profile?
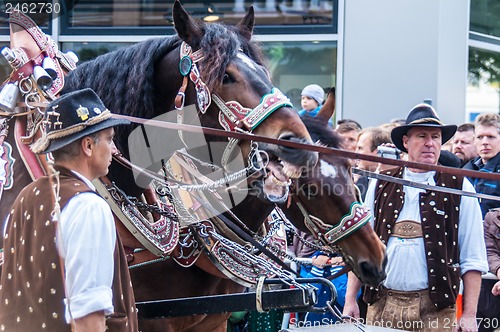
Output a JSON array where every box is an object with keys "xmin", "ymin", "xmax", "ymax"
[{"xmin": 0, "ymin": 168, "xmax": 138, "ymax": 332}]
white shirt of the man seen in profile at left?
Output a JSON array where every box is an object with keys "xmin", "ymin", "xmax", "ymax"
[{"xmin": 57, "ymin": 171, "xmax": 116, "ymax": 323}]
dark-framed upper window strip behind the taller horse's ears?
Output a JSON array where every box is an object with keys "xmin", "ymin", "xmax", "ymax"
[{"xmin": 63, "ymin": 0, "xmax": 338, "ymax": 34}]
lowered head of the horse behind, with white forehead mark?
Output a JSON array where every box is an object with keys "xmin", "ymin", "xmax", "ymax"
[{"xmin": 284, "ymin": 117, "xmax": 385, "ymax": 286}]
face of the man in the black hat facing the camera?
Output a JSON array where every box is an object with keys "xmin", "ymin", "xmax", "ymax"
[{"xmin": 403, "ymin": 127, "xmax": 441, "ymax": 172}]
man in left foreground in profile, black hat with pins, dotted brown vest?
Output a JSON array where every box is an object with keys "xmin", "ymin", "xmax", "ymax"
[{"xmin": 0, "ymin": 89, "xmax": 138, "ymax": 332}]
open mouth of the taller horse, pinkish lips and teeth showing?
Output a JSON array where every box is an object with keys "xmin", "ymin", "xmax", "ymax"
[{"xmin": 254, "ymin": 159, "xmax": 301, "ymax": 203}]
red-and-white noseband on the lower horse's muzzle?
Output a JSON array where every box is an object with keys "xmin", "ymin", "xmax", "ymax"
[{"xmin": 294, "ymin": 196, "xmax": 370, "ymax": 246}]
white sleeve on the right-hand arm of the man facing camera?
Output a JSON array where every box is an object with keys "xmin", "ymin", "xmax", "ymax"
[{"xmin": 458, "ymin": 179, "xmax": 488, "ymax": 274}]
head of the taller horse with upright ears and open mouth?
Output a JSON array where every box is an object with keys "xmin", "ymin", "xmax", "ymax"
[{"xmin": 157, "ymin": 1, "xmax": 317, "ymax": 201}]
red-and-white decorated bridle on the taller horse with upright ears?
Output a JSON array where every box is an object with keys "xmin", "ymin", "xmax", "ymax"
[{"xmin": 174, "ymin": 42, "xmax": 293, "ymax": 168}]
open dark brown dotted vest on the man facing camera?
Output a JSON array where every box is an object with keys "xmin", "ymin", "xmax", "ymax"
[{"xmin": 364, "ymin": 167, "xmax": 463, "ymax": 309}]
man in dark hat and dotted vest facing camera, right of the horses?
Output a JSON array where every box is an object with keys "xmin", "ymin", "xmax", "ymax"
[{"xmin": 344, "ymin": 104, "xmax": 488, "ymax": 331}]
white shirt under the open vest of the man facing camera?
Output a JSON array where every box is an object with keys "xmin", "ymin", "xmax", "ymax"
[{"xmin": 366, "ymin": 169, "xmax": 488, "ymax": 291}]
